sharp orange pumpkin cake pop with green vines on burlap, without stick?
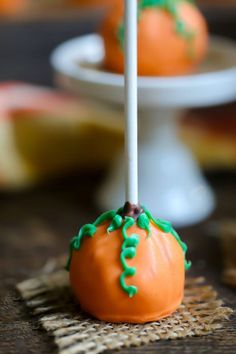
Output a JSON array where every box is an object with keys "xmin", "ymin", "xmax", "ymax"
[{"xmin": 67, "ymin": 203, "xmax": 190, "ymax": 323}]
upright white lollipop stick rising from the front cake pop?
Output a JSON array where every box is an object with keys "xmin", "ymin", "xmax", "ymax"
[{"xmin": 125, "ymin": 0, "xmax": 138, "ymax": 204}]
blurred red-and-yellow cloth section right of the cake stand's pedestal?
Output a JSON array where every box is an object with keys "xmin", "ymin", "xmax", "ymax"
[{"xmin": 180, "ymin": 109, "xmax": 236, "ymax": 169}]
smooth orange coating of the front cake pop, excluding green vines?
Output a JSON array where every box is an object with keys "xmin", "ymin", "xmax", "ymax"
[{"xmin": 70, "ymin": 222, "xmax": 185, "ymax": 323}]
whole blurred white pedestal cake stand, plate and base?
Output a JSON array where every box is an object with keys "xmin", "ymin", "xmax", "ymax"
[{"xmin": 51, "ymin": 35, "xmax": 236, "ymax": 226}]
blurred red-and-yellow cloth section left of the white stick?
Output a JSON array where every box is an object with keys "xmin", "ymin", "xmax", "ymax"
[{"xmin": 0, "ymin": 84, "xmax": 123, "ymax": 188}]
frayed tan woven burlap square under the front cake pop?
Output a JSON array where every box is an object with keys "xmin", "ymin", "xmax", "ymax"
[{"xmin": 17, "ymin": 258, "xmax": 232, "ymax": 354}]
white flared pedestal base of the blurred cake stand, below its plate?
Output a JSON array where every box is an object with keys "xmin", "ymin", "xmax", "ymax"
[{"xmin": 98, "ymin": 109, "xmax": 215, "ymax": 226}]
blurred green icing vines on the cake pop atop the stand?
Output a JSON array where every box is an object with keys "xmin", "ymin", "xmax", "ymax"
[{"xmin": 117, "ymin": 0, "xmax": 195, "ymax": 56}]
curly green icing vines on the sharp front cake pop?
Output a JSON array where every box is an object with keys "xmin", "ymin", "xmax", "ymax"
[{"xmin": 66, "ymin": 206, "xmax": 191, "ymax": 297}]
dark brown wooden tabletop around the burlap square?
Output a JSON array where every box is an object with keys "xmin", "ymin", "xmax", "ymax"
[{"xmin": 0, "ymin": 173, "xmax": 236, "ymax": 354}]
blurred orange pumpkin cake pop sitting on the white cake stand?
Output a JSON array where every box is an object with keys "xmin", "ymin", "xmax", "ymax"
[{"xmin": 101, "ymin": 0, "xmax": 208, "ymax": 76}]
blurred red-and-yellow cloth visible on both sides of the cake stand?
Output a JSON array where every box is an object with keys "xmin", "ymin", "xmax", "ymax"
[{"xmin": 0, "ymin": 83, "xmax": 236, "ymax": 189}]
